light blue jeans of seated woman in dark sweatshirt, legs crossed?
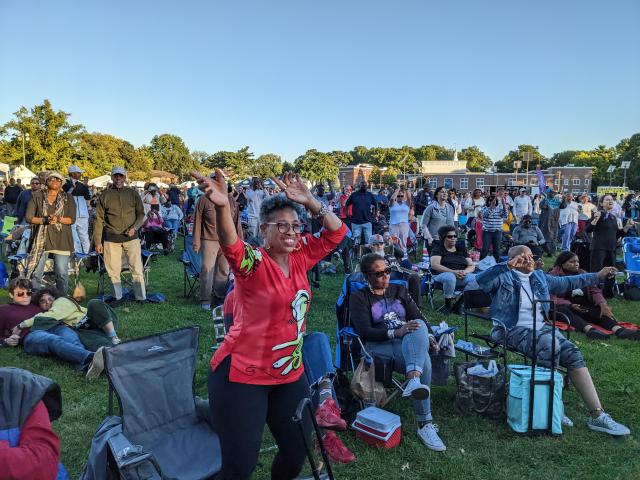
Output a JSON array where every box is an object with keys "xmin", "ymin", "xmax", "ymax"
[{"xmin": 365, "ymin": 324, "xmax": 433, "ymax": 422}]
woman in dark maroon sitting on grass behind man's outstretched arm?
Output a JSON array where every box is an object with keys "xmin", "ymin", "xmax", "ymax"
[{"xmin": 549, "ymin": 251, "xmax": 640, "ymax": 340}]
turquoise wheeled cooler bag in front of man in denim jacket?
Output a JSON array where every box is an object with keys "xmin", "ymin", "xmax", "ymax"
[{"xmin": 507, "ymin": 365, "xmax": 564, "ymax": 435}]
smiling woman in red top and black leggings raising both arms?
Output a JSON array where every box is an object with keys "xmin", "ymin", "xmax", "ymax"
[{"xmin": 193, "ymin": 170, "xmax": 347, "ymax": 480}]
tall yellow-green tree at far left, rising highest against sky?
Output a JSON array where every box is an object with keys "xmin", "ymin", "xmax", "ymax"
[{"xmin": 0, "ymin": 100, "xmax": 85, "ymax": 172}]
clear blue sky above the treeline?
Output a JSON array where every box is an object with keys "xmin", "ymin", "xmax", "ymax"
[{"xmin": 0, "ymin": 0, "xmax": 640, "ymax": 160}]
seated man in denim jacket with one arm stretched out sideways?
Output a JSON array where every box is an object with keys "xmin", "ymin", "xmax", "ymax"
[{"xmin": 476, "ymin": 245, "xmax": 631, "ymax": 435}]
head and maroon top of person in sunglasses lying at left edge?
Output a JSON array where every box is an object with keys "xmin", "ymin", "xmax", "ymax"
[{"xmin": 0, "ymin": 278, "xmax": 42, "ymax": 347}]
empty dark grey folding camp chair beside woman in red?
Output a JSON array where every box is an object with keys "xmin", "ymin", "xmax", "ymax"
[{"xmin": 104, "ymin": 326, "xmax": 222, "ymax": 480}]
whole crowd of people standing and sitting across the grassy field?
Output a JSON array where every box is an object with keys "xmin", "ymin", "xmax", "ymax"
[{"xmin": 0, "ymin": 170, "xmax": 640, "ymax": 479}]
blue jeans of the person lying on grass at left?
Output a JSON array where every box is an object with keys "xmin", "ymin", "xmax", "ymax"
[{"xmin": 24, "ymin": 325, "xmax": 93, "ymax": 368}]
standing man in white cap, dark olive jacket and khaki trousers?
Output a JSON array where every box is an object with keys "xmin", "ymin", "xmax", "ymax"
[{"xmin": 93, "ymin": 167, "xmax": 147, "ymax": 302}]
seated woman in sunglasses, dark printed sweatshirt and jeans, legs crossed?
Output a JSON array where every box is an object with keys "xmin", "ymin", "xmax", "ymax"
[{"xmin": 349, "ymin": 253, "xmax": 446, "ymax": 452}]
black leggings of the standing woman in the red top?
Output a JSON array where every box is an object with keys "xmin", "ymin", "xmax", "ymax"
[{"xmin": 209, "ymin": 356, "xmax": 313, "ymax": 480}]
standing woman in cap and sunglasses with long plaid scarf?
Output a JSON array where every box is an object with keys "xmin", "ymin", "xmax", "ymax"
[{"xmin": 25, "ymin": 172, "xmax": 76, "ymax": 292}]
